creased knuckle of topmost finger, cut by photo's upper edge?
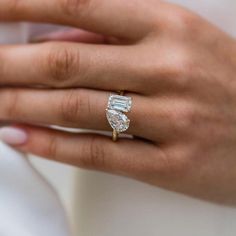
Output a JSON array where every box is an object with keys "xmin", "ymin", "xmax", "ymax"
[{"xmin": 60, "ymin": 0, "xmax": 91, "ymax": 17}]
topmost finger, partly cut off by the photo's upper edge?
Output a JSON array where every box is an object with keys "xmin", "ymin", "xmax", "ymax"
[{"xmin": 0, "ymin": 0, "xmax": 157, "ymax": 38}]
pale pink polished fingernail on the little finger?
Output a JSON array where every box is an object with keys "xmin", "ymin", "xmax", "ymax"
[{"xmin": 0, "ymin": 127, "xmax": 28, "ymax": 145}]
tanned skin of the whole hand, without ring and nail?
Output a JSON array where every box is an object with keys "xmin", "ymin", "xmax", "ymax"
[{"xmin": 0, "ymin": 0, "xmax": 236, "ymax": 204}]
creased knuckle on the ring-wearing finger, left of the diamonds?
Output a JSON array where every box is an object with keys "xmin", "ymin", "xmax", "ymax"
[{"xmin": 60, "ymin": 89, "xmax": 91, "ymax": 124}]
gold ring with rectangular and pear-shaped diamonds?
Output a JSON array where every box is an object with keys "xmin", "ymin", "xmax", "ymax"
[{"xmin": 106, "ymin": 92, "xmax": 132, "ymax": 142}]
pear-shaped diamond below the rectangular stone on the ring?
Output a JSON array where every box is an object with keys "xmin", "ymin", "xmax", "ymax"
[{"xmin": 107, "ymin": 109, "xmax": 130, "ymax": 133}]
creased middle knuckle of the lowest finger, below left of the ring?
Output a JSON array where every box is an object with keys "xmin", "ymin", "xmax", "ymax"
[{"xmin": 81, "ymin": 136, "xmax": 106, "ymax": 169}]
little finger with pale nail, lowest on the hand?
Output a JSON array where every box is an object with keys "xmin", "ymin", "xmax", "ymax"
[{"xmin": 0, "ymin": 126, "xmax": 164, "ymax": 175}]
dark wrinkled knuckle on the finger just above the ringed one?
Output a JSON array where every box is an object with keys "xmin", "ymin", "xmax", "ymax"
[{"xmin": 44, "ymin": 45, "xmax": 80, "ymax": 86}]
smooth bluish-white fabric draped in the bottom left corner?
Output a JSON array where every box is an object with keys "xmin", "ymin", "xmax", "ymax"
[{"xmin": 0, "ymin": 143, "xmax": 70, "ymax": 236}]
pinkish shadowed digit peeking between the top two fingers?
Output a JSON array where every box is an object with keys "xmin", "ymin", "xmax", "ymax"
[{"xmin": 30, "ymin": 29, "xmax": 106, "ymax": 44}]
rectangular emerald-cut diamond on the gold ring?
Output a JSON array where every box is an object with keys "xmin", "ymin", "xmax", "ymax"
[{"xmin": 108, "ymin": 95, "xmax": 132, "ymax": 112}]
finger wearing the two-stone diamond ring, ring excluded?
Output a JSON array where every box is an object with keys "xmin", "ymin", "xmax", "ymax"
[{"xmin": 0, "ymin": 89, "xmax": 175, "ymax": 143}]
